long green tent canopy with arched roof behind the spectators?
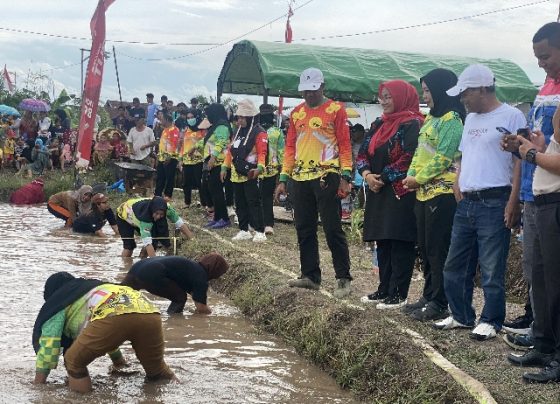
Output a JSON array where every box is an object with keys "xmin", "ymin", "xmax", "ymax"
[{"xmin": 218, "ymin": 41, "xmax": 537, "ymax": 103}]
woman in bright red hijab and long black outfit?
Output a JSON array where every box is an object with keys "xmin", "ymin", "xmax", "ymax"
[{"xmin": 356, "ymin": 80, "xmax": 424, "ymax": 309}]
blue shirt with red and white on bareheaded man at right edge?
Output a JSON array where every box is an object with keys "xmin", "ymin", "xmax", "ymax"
[{"xmin": 519, "ymin": 78, "xmax": 560, "ymax": 202}]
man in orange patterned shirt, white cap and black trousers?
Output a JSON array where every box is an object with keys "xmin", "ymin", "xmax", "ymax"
[{"xmin": 276, "ymin": 68, "xmax": 352, "ymax": 298}]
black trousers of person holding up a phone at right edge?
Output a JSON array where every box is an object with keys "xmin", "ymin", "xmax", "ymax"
[{"xmin": 531, "ymin": 202, "xmax": 560, "ymax": 360}]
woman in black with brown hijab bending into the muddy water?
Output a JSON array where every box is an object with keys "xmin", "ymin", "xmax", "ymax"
[{"xmin": 121, "ymin": 253, "xmax": 229, "ymax": 314}]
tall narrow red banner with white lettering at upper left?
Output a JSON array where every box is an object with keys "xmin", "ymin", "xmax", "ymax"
[{"xmin": 76, "ymin": 0, "xmax": 115, "ymax": 168}]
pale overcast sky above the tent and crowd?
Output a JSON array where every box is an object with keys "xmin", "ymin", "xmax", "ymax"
[{"xmin": 0, "ymin": 0, "xmax": 558, "ymax": 107}]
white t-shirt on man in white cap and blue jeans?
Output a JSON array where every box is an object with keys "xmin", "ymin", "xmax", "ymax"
[{"xmin": 459, "ymin": 104, "xmax": 527, "ymax": 192}]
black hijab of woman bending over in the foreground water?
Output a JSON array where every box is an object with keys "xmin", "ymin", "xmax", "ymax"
[{"xmin": 32, "ymin": 272, "xmax": 106, "ymax": 353}]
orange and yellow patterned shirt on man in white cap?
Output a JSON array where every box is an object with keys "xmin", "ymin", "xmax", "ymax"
[{"xmin": 280, "ymin": 99, "xmax": 352, "ymax": 181}]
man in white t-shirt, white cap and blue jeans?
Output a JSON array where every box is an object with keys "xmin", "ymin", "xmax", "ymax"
[{"xmin": 435, "ymin": 65, "xmax": 527, "ymax": 341}]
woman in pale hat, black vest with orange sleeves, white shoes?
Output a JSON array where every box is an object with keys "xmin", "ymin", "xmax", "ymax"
[{"xmin": 221, "ymin": 99, "xmax": 268, "ymax": 242}]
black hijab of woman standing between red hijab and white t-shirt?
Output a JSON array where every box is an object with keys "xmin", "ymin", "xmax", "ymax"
[{"xmin": 420, "ymin": 69, "xmax": 467, "ymax": 122}]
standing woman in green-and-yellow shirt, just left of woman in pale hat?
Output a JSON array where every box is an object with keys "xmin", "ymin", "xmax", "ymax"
[{"xmin": 197, "ymin": 104, "xmax": 232, "ymax": 229}]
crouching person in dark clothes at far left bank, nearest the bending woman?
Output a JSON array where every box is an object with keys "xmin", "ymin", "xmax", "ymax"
[{"xmin": 72, "ymin": 194, "xmax": 119, "ymax": 237}]
